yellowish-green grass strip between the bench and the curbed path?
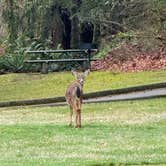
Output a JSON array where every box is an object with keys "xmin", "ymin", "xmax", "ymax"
[{"xmin": 0, "ymin": 70, "xmax": 166, "ymax": 102}]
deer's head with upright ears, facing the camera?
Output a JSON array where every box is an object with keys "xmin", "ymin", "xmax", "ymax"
[{"xmin": 71, "ymin": 69, "xmax": 90, "ymax": 86}]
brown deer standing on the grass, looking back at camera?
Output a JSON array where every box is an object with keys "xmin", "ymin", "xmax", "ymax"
[{"xmin": 65, "ymin": 70, "xmax": 90, "ymax": 128}]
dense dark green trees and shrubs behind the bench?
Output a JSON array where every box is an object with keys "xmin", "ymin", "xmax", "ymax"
[{"xmin": 0, "ymin": 0, "xmax": 166, "ymax": 71}]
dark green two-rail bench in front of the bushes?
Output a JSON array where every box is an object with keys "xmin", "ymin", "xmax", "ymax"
[{"xmin": 25, "ymin": 49, "xmax": 97, "ymax": 73}]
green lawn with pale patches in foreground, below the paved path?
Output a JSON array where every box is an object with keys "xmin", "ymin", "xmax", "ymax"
[{"xmin": 0, "ymin": 98, "xmax": 166, "ymax": 166}]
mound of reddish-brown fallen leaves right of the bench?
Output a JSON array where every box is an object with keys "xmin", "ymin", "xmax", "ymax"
[{"xmin": 92, "ymin": 44, "xmax": 166, "ymax": 72}]
